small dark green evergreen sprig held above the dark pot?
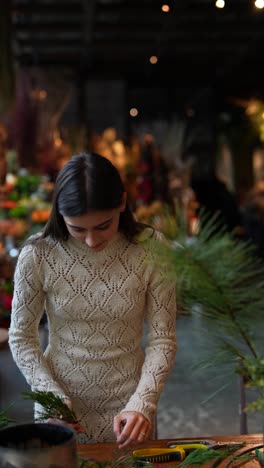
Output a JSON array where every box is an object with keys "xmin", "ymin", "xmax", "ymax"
[{"xmin": 22, "ymin": 391, "xmax": 78, "ymax": 424}]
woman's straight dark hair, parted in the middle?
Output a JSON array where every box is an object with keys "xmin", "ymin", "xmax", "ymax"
[{"xmin": 40, "ymin": 153, "xmax": 145, "ymax": 241}]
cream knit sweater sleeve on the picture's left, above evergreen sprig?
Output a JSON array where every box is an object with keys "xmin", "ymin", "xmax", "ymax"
[{"xmin": 9, "ymin": 245, "xmax": 65, "ymax": 396}]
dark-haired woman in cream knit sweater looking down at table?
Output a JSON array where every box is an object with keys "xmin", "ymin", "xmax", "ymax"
[{"xmin": 9, "ymin": 153, "xmax": 176, "ymax": 447}]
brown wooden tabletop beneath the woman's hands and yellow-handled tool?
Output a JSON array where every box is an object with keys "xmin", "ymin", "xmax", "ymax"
[{"xmin": 78, "ymin": 434, "xmax": 264, "ymax": 468}]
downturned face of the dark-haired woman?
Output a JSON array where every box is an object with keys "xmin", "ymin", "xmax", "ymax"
[{"xmin": 63, "ymin": 196, "xmax": 126, "ymax": 252}]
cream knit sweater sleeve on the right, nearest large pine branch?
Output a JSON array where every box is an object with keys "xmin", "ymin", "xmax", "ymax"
[{"xmin": 124, "ymin": 238, "xmax": 177, "ymax": 420}]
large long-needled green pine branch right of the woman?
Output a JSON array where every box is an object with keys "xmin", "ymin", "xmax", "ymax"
[{"xmin": 152, "ymin": 212, "xmax": 264, "ymax": 410}]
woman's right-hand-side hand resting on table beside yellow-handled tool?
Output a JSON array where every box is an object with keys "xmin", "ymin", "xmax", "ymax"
[{"xmin": 114, "ymin": 411, "xmax": 152, "ymax": 448}]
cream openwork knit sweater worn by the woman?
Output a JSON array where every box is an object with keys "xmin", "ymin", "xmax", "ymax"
[{"xmin": 9, "ymin": 233, "xmax": 176, "ymax": 442}]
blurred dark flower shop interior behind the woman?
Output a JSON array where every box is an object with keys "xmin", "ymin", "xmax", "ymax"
[{"xmin": 0, "ymin": 0, "xmax": 264, "ymax": 437}]
